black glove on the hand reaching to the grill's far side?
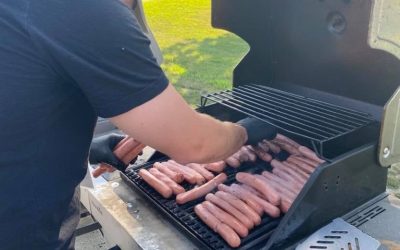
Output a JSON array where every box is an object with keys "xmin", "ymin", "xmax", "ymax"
[{"xmin": 237, "ymin": 117, "xmax": 277, "ymax": 145}]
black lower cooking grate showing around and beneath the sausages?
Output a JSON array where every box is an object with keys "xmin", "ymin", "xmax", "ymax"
[{"xmin": 123, "ymin": 163, "xmax": 280, "ymax": 250}]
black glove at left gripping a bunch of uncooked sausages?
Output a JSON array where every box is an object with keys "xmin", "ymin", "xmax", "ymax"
[{"xmin": 89, "ymin": 134, "xmax": 126, "ymax": 171}]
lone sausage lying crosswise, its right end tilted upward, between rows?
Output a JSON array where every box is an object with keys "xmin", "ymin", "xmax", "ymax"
[{"xmin": 176, "ymin": 173, "xmax": 228, "ymax": 204}]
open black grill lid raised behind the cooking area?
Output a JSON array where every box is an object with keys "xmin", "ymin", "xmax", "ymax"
[{"xmin": 212, "ymin": 0, "xmax": 400, "ymax": 114}]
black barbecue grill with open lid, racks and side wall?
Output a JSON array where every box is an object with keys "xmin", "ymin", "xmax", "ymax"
[{"xmin": 123, "ymin": 0, "xmax": 400, "ymax": 249}]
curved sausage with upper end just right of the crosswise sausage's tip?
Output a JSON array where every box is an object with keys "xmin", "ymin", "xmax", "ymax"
[{"xmin": 236, "ymin": 172, "xmax": 280, "ymax": 206}]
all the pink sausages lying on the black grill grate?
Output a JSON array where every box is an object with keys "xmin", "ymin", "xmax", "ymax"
[{"xmin": 139, "ymin": 134, "xmax": 324, "ymax": 247}]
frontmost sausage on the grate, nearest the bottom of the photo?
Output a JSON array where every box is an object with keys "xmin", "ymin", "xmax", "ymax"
[{"xmin": 194, "ymin": 204, "xmax": 240, "ymax": 247}]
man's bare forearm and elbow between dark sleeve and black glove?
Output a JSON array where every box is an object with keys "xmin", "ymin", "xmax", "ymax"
[{"xmin": 111, "ymin": 85, "xmax": 247, "ymax": 163}]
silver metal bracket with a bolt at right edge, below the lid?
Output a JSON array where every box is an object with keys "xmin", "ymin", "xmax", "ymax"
[{"xmin": 378, "ymin": 87, "xmax": 400, "ymax": 167}]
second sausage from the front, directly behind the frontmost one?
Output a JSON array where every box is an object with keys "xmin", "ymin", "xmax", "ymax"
[{"xmin": 202, "ymin": 201, "xmax": 249, "ymax": 238}]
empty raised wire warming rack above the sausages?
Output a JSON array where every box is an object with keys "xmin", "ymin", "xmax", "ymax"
[{"xmin": 201, "ymin": 84, "xmax": 375, "ymax": 143}]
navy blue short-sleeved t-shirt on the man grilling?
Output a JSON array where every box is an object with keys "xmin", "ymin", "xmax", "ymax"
[{"xmin": 0, "ymin": 0, "xmax": 168, "ymax": 249}]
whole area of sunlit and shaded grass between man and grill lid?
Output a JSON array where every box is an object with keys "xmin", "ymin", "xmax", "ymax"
[{"xmin": 144, "ymin": 0, "xmax": 248, "ymax": 105}]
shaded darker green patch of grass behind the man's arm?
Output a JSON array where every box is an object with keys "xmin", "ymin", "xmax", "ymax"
[{"xmin": 162, "ymin": 34, "xmax": 248, "ymax": 105}]
